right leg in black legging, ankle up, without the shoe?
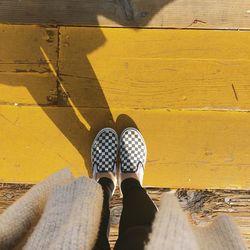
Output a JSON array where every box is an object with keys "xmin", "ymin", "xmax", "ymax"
[{"xmin": 115, "ymin": 178, "xmax": 157, "ymax": 250}]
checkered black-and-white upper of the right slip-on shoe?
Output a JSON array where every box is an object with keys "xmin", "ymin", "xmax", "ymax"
[{"xmin": 120, "ymin": 128, "xmax": 146, "ymax": 173}]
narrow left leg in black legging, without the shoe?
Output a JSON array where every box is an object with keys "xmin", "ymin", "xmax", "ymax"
[{"xmin": 94, "ymin": 177, "xmax": 115, "ymax": 250}]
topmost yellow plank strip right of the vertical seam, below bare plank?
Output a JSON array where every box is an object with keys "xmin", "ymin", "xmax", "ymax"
[{"xmin": 60, "ymin": 27, "xmax": 250, "ymax": 60}]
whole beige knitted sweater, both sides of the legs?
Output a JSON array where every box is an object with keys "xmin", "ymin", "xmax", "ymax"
[{"xmin": 0, "ymin": 169, "xmax": 247, "ymax": 250}]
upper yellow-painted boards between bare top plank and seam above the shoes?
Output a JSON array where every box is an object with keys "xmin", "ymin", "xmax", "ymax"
[{"xmin": 0, "ymin": 25, "xmax": 250, "ymax": 110}]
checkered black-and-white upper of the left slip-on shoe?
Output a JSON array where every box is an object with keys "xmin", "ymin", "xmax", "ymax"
[{"xmin": 91, "ymin": 129, "xmax": 118, "ymax": 172}]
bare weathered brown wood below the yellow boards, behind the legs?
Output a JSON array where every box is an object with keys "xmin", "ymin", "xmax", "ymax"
[{"xmin": 0, "ymin": 184, "xmax": 250, "ymax": 247}]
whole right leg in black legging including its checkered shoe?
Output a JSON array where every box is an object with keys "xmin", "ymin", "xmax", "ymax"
[{"xmin": 115, "ymin": 128, "xmax": 157, "ymax": 250}]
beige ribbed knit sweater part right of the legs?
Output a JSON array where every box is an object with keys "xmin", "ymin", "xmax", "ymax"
[{"xmin": 145, "ymin": 194, "xmax": 247, "ymax": 250}]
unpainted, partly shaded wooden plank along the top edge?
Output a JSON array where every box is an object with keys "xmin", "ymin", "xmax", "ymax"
[{"xmin": 0, "ymin": 0, "xmax": 250, "ymax": 29}]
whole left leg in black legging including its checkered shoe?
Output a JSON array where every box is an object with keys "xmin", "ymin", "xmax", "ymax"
[{"xmin": 91, "ymin": 128, "xmax": 118, "ymax": 250}]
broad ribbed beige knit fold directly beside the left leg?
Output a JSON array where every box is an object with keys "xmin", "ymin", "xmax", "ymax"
[{"xmin": 24, "ymin": 177, "xmax": 103, "ymax": 250}]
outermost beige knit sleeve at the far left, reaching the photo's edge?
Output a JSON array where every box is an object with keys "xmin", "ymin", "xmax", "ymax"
[{"xmin": 0, "ymin": 169, "xmax": 73, "ymax": 250}]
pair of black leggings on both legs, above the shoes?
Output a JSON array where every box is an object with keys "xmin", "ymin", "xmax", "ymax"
[{"xmin": 94, "ymin": 177, "xmax": 157, "ymax": 250}]
